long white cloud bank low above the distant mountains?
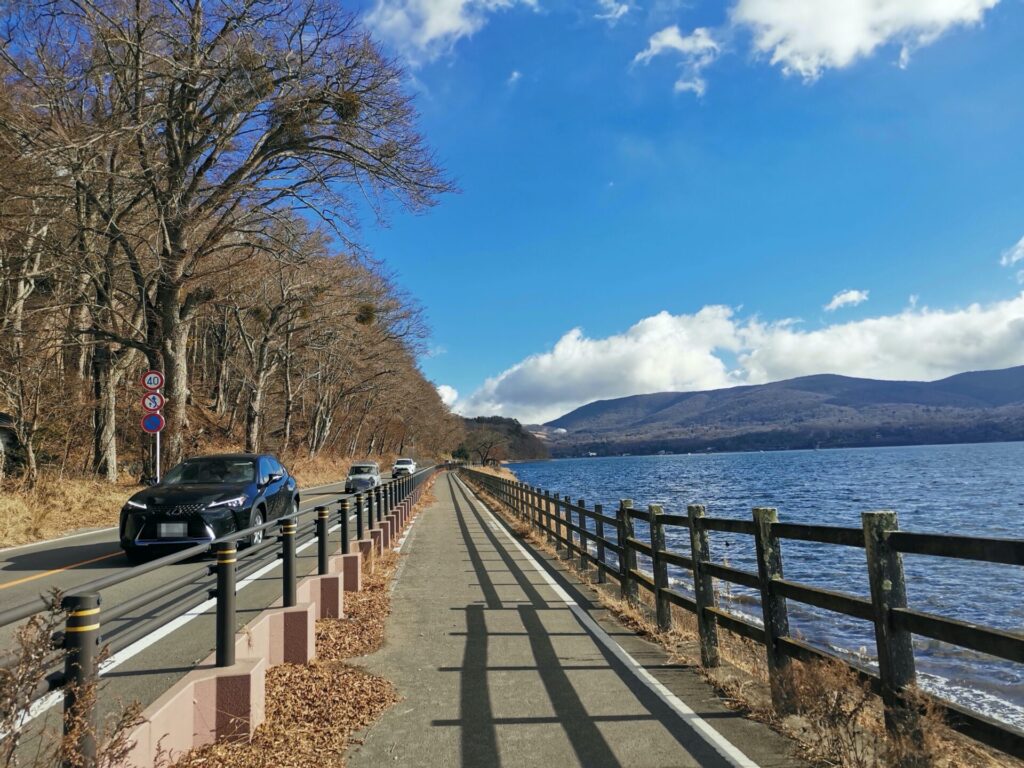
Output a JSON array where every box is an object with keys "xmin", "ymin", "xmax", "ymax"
[{"xmin": 458, "ymin": 293, "xmax": 1024, "ymax": 423}]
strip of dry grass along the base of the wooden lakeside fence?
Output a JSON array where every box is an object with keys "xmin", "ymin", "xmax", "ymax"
[{"xmin": 473, "ymin": 479, "xmax": 1024, "ymax": 768}]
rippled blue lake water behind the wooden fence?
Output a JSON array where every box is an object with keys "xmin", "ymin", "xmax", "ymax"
[{"xmin": 511, "ymin": 442, "xmax": 1024, "ymax": 728}]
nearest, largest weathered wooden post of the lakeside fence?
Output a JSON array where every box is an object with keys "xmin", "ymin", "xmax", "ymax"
[{"xmin": 860, "ymin": 511, "xmax": 922, "ymax": 765}]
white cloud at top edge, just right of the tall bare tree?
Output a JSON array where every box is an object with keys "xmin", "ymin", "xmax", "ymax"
[{"xmin": 366, "ymin": 0, "xmax": 537, "ymax": 62}]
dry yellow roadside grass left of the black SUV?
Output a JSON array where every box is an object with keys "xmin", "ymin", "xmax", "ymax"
[{"xmin": 0, "ymin": 476, "xmax": 141, "ymax": 547}]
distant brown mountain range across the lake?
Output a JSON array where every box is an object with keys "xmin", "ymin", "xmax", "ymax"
[{"xmin": 541, "ymin": 366, "xmax": 1024, "ymax": 456}]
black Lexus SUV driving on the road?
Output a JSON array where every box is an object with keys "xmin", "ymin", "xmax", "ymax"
[{"xmin": 121, "ymin": 454, "xmax": 299, "ymax": 562}]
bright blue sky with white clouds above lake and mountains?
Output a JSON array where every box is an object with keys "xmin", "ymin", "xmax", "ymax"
[{"xmin": 350, "ymin": 0, "xmax": 1024, "ymax": 421}]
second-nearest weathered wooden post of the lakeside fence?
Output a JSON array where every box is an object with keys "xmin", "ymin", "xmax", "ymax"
[{"xmin": 754, "ymin": 507, "xmax": 795, "ymax": 715}]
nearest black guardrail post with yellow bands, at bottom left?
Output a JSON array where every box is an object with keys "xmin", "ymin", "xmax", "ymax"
[{"xmin": 60, "ymin": 592, "xmax": 100, "ymax": 768}]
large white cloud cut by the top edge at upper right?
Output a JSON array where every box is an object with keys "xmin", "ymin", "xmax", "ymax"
[{"xmin": 730, "ymin": 0, "xmax": 999, "ymax": 80}]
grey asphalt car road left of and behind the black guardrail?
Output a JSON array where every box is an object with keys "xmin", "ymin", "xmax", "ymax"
[{"xmin": 0, "ymin": 477, "xmax": 401, "ymax": 761}]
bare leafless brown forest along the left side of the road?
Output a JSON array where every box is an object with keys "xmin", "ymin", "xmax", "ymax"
[{"xmin": 0, "ymin": 0, "xmax": 461, "ymax": 499}]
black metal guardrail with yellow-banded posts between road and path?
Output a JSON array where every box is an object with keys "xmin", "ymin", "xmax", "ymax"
[{"xmin": 0, "ymin": 465, "xmax": 440, "ymax": 765}]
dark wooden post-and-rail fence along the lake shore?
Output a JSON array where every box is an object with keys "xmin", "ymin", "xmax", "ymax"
[{"xmin": 460, "ymin": 467, "xmax": 1024, "ymax": 758}]
